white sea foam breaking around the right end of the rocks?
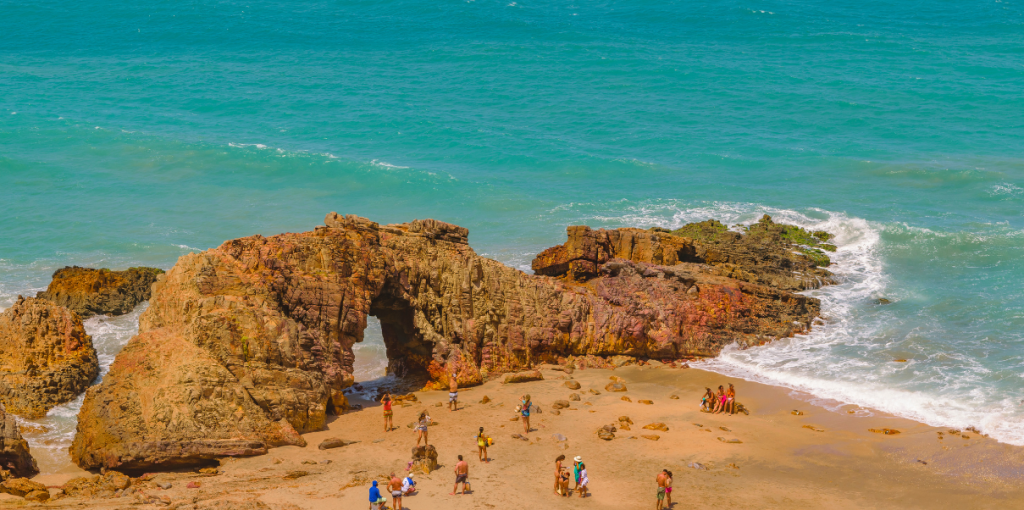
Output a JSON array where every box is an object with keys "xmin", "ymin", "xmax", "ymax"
[{"xmin": 565, "ymin": 201, "xmax": 1024, "ymax": 444}]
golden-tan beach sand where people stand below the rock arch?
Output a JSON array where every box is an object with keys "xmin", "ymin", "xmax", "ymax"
[{"xmin": 14, "ymin": 366, "xmax": 1024, "ymax": 510}]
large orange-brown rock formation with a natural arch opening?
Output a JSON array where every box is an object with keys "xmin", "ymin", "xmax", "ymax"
[{"xmin": 71, "ymin": 213, "xmax": 818, "ymax": 470}]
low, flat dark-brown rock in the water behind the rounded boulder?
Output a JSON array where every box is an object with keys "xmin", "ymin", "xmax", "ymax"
[{"xmin": 36, "ymin": 266, "xmax": 164, "ymax": 317}]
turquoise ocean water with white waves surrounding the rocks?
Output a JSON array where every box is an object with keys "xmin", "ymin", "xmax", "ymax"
[{"xmin": 0, "ymin": 0, "xmax": 1024, "ymax": 469}]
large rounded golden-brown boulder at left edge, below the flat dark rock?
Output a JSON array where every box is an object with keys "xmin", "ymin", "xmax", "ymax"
[{"xmin": 0, "ymin": 297, "xmax": 99, "ymax": 418}]
